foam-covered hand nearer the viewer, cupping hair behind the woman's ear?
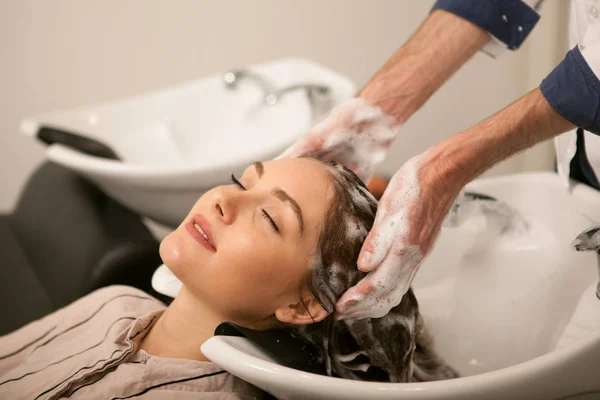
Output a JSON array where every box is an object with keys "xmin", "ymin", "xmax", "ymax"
[{"xmin": 337, "ymin": 151, "xmax": 461, "ymax": 319}]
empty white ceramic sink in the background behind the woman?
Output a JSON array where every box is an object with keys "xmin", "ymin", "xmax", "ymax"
[{"xmin": 21, "ymin": 59, "xmax": 355, "ymax": 226}]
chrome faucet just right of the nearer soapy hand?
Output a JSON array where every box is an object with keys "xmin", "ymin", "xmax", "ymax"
[{"xmin": 444, "ymin": 191, "xmax": 529, "ymax": 234}]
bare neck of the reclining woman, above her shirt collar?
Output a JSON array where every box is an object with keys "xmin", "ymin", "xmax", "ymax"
[{"xmin": 140, "ymin": 286, "xmax": 225, "ymax": 361}]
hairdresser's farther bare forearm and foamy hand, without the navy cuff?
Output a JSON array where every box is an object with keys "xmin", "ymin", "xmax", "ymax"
[{"xmin": 279, "ymin": 9, "xmax": 491, "ymax": 181}]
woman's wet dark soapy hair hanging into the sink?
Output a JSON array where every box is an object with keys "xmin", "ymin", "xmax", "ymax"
[{"xmin": 283, "ymin": 162, "xmax": 458, "ymax": 382}]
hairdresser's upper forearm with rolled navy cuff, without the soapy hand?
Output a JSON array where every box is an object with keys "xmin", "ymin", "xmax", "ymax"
[{"xmin": 360, "ymin": 0, "xmax": 540, "ymax": 123}]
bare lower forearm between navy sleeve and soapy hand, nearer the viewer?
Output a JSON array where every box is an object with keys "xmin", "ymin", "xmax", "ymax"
[{"xmin": 426, "ymin": 88, "xmax": 574, "ymax": 196}]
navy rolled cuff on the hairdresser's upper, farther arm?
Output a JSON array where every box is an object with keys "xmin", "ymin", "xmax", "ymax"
[{"xmin": 433, "ymin": 0, "xmax": 540, "ymax": 50}]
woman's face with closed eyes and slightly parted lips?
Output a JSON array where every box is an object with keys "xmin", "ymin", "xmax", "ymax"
[{"xmin": 160, "ymin": 158, "xmax": 334, "ymax": 323}]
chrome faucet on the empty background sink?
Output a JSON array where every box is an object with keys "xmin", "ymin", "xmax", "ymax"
[{"xmin": 223, "ymin": 70, "xmax": 333, "ymax": 122}]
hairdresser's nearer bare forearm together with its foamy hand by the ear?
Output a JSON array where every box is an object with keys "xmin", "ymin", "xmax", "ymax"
[{"xmin": 338, "ymin": 88, "xmax": 574, "ymax": 318}]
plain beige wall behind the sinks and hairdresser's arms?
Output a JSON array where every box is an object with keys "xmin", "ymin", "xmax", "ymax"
[{"xmin": 0, "ymin": 0, "xmax": 566, "ymax": 211}]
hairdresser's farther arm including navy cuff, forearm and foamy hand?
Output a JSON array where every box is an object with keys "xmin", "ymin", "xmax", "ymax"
[{"xmin": 280, "ymin": 0, "xmax": 539, "ymax": 182}]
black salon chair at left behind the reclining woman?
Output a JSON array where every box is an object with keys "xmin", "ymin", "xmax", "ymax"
[{"xmin": 0, "ymin": 162, "xmax": 163, "ymax": 335}]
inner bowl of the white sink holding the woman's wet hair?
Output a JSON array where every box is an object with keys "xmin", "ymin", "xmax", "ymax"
[{"xmin": 413, "ymin": 173, "xmax": 600, "ymax": 376}]
